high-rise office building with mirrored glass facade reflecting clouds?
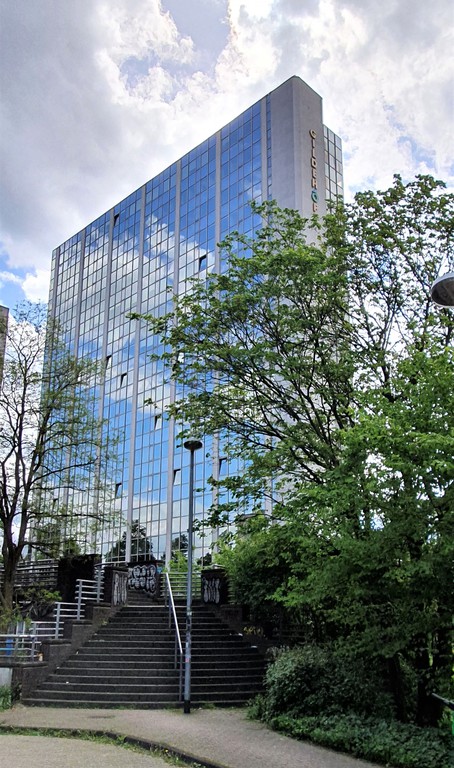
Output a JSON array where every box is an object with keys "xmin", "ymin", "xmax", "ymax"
[{"xmin": 50, "ymin": 77, "xmax": 342, "ymax": 561}]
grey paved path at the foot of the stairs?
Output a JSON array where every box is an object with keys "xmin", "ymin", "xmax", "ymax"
[{"xmin": 0, "ymin": 704, "xmax": 377, "ymax": 768}]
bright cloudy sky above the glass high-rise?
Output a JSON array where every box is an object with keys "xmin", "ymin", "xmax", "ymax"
[{"xmin": 0, "ymin": 0, "xmax": 454, "ymax": 307}]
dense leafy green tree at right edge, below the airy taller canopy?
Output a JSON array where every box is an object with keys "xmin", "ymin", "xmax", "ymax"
[{"xmin": 300, "ymin": 348, "xmax": 454, "ymax": 724}]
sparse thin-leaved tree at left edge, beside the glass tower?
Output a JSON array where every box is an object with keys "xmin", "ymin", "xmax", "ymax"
[{"xmin": 0, "ymin": 304, "xmax": 110, "ymax": 615}]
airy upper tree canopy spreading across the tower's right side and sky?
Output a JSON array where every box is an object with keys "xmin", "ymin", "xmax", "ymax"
[{"xmin": 137, "ymin": 177, "xmax": 453, "ymax": 519}]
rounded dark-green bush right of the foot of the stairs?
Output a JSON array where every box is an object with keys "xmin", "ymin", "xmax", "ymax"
[{"xmin": 258, "ymin": 645, "xmax": 393, "ymax": 718}]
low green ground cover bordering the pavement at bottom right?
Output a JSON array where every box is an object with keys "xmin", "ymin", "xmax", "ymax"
[{"xmin": 268, "ymin": 715, "xmax": 454, "ymax": 768}]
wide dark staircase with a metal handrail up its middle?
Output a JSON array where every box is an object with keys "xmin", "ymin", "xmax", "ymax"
[{"xmin": 23, "ymin": 595, "xmax": 264, "ymax": 709}]
